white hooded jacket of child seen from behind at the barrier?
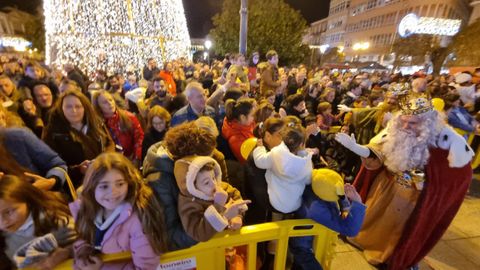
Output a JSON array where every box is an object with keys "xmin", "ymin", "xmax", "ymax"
[{"xmin": 253, "ymin": 142, "xmax": 313, "ymax": 213}]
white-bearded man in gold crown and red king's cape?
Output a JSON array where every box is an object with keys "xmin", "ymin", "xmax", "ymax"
[{"xmin": 336, "ymin": 93, "xmax": 474, "ymax": 270}]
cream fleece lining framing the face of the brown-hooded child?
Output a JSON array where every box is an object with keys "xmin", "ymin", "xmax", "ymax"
[{"xmin": 184, "ymin": 156, "xmax": 222, "ymax": 201}]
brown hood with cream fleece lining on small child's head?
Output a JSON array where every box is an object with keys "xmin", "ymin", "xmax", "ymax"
[{"xmin": 173, "ymin": 156, "xmax": 222, "ymax": 201}]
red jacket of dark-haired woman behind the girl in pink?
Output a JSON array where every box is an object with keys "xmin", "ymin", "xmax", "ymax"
[{"xmin": 105, "ymin": 111, "xmax": 144, "ymax": 160}]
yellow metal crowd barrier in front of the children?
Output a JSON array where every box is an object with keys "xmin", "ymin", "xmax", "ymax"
[{"xmin": 56, "ymin": 219, "xmax": 338, "ymax": 270}]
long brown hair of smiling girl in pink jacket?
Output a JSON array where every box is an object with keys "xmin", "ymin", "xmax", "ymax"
[{"xmin": 75, "ymin": 153, "xmax": 167, "ymax": 253}]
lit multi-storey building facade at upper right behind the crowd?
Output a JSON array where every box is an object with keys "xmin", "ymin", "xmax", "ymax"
[{"xmin": 306, "ymin": 0, "xmax": 471, "ymax": 64}]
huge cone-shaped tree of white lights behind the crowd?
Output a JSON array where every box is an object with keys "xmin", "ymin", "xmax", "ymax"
[{"xmin": 43, "ymin": 0, "xmax": 190, "ymax": 73}]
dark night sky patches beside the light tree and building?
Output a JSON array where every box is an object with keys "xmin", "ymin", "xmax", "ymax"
[{"xmin": 0, "ymin": 0, "xmax": 330, "ymax": 38}]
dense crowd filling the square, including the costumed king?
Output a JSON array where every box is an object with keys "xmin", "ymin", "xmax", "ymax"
[{"xmin": 0, "ymin": 50, "xmax": 480, "ymax": 269}]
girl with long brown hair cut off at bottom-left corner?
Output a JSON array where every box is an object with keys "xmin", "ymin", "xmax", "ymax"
[{"xmin": 0, "ymin": 175, "xmax": 76, "ymax": 269}]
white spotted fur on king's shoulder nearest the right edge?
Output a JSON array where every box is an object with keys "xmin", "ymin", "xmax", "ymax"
[{"xmin": 437, "ymin": 126, "xmax": 475, "ymax": 168}]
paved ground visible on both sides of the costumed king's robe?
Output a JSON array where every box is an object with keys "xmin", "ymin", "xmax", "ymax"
[{"xmin": 332, "ymin": 177, "xmax": 480, "ymax": 270}]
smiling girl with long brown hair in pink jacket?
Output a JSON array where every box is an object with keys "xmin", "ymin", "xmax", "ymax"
[{"xmin": 70, "ymin": 153, "xmax": 166, "ymax": 269}]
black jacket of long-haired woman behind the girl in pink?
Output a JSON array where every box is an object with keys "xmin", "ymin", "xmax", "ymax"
[{"xmin": 42, "ymin": 118, "xmax": 115, "ymax": 187}]
